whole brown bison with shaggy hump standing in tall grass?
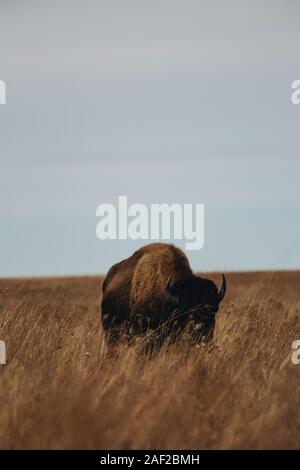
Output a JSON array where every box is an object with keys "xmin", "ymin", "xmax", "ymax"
[{"xmin": 101, "ymin": 243, "xmax": 226, "ymax": 342}]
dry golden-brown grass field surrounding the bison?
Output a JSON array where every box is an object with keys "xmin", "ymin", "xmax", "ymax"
[{"xmin": 0, "ymin": 272, "xmax": 300, "ymax": 449}]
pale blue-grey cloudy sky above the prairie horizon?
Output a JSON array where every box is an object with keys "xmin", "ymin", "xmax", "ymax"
[{"xmin": 0, "ymin": 0, "xmax": 300, "ymax": 277}]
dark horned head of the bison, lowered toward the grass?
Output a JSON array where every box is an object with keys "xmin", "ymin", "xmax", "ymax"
[{"xmin": 166, "ymin": 274, "xmax": 226, "ymax": 342}]
